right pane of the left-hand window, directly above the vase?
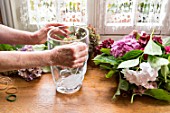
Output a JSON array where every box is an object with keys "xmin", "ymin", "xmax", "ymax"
[{"xmin": 58, "ymin": 0, "xmax": 87, "ymax": 24}]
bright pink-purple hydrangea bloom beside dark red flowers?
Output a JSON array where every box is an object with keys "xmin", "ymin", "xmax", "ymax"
[{"xmin": 111, "ymin": 35, "xmax": 140, "ymax": 58}]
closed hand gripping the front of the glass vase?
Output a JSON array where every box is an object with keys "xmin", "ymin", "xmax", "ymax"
[{"xmin": 51, "ymin": 42, "xmax": 88, "ymax": 68}]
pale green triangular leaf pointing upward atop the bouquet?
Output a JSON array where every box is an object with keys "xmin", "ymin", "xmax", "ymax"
[{"xmin": 144, "ymin": 37, "xmax": 162, "ymax": 55}]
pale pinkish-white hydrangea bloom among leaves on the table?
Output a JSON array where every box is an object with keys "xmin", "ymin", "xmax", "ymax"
[{"xmin": 121, "ymin": 62, "xmax": 158, "ymax": 89}]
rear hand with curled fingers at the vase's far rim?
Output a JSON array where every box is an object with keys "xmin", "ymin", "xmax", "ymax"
[{"xmin": 33, "ymin": 23, "xmax": 70, "ymax": 44}]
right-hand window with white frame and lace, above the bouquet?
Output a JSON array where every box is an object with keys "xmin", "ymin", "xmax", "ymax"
[{"xmin": 97, "ymin": 0, "xmax": 169, "ymax": 34}]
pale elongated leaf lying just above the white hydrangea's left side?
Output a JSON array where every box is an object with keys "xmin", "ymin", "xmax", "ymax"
[{"xmin": 118, "ymin": 58, "xmax": 139, "ymax": 68}]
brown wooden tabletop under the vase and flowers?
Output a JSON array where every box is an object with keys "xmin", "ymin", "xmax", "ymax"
[{"xmin": 0, "ymin": 66, "xmax": 170, "ymax": 113}]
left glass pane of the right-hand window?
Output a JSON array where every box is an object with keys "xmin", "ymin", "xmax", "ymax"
[{"xmin": 106, "ymin": 0, "xmax": 134, "ymax": 25}]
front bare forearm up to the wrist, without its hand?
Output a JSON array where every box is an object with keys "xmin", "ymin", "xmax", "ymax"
[{"xmin": 0, "ymin": 51, "xmax": 51, "ymax": 72}]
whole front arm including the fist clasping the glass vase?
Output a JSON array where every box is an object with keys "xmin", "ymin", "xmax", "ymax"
[{"xmin": 0, "ymin": 42, "xmax": 88, "ymax": 72}]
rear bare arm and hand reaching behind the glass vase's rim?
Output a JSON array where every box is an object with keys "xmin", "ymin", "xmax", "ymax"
[{"xmin": 0, "ymin": 23, "xmax": 69, "ymax": 45}]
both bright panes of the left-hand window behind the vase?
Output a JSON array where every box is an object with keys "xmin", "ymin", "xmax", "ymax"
[{"xmin": 28, "ymin": 0, "xmax": 87, "ymax": 24}]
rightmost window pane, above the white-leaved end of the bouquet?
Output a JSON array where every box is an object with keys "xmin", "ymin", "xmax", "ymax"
[{"xmin": 136, "ymin": 0, "xmax": 163, "ymax": 24}]
